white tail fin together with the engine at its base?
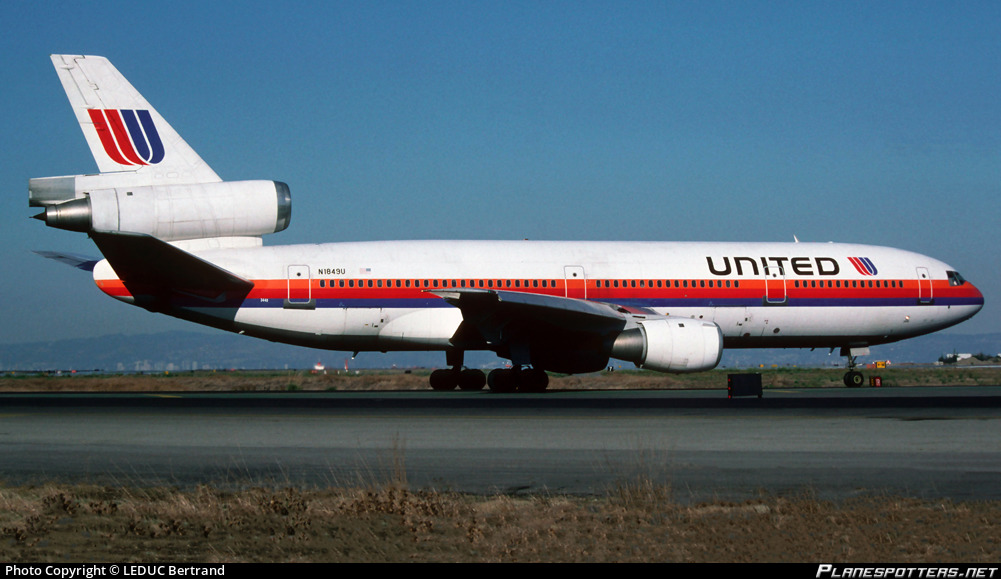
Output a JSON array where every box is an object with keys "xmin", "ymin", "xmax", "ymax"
[{"xmin": 28, "ymin": 54, "xmax": 292, "ymax": 240}]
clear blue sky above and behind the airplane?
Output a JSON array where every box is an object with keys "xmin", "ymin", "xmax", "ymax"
[{"xmin": 0, "ymin": 0, "xmax": 1001, "ymax": 343}]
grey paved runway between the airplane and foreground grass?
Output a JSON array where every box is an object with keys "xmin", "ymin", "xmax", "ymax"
[{"xmin": 0, "ymin": 387, "xmax": 1001, "ymax": 501}]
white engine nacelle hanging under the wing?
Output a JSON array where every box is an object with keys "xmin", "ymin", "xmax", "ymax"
[{"xmin": 612, "ymin": 318, "xmax": 723, "ymax": 374}]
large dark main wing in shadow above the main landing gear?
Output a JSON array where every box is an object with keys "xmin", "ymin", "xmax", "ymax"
[{"xmin": 431, "ymin": 287, "xmax": 629, "ymax": 372}]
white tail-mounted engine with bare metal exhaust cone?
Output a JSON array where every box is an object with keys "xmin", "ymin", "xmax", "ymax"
[{"xmin": 35, "ymin": 181, "xmax": 292, "ymax": 241}]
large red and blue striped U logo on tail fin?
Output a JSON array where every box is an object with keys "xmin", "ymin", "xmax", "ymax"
[{"xmin": 87, "ymin": 108, "xmax": 163, "ymax": 165}]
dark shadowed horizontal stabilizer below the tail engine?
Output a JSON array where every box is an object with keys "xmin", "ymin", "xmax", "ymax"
[{"xmin": 90, "ymin": 231, "xmax": 253, "ymax": 303}]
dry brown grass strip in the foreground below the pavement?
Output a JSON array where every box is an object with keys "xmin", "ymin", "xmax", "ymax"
[{"xmin": 0, "ymin": 484, "xmax": 1001, "ymax": 563}]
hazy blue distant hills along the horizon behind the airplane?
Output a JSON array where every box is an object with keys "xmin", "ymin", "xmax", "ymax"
[{"xmin": 0, "ymin": 332, "xmax": 1001, "ymax": 372}]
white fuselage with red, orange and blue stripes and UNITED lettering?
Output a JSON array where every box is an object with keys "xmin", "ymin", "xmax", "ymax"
[{"xmin": 94, "ymin": 236, "xmax": 983, "ymax": 351}]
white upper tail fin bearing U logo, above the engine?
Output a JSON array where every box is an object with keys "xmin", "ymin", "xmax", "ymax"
[{"xmin": 51, "ymin": 54, "xmax": 221, "ymax": 185}]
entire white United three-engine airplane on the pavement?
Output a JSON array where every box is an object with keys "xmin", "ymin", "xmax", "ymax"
[{"xmin": 28, "ymin": 55, "xmax": 984, "ymax": 392}]
